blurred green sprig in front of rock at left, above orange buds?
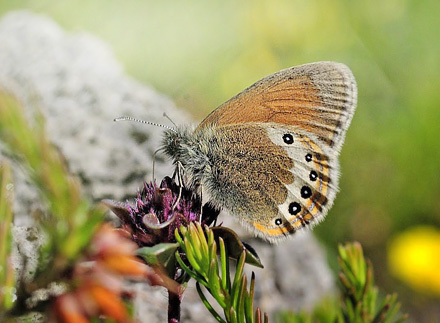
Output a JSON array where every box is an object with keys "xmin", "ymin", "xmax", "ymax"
[{"xmin": 0, "ymin": 91, "xmax": 104, "ymax": 270}]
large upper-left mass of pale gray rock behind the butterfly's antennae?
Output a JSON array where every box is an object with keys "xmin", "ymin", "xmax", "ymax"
[{"xmin": 0, "ymin": 12, "xmax": 188, "ymax": 223}]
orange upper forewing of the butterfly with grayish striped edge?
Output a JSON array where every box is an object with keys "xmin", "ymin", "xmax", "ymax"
[{"xmin": 198, "ymin": 62, "xmax": 357, "ymax": 151}]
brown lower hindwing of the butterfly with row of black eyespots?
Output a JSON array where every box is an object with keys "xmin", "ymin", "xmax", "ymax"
[{"xmin": 205, "ymin": 123, "xmax": 338, "ymax": 242}]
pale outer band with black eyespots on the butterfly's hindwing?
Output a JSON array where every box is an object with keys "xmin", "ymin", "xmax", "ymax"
[{"xmin": 248, "ymin": 124, "xmax": 339, "ymax": 241}]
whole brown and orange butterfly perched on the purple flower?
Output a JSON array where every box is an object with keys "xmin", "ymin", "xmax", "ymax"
[{"xmin": 163, "ymin": 62, "xmax": 357, "ymax": 242}]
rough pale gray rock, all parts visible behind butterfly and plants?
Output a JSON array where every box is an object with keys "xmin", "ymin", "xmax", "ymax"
[{"xmin": 0, "ymin": 11, "xmax": 333, "ymax": 322}]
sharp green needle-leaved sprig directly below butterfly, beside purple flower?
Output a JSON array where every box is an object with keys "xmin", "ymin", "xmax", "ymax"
[{"xmin": 176, "ymin": 223, "xmax": 263, "ymax": 323}]
